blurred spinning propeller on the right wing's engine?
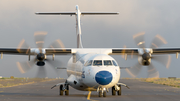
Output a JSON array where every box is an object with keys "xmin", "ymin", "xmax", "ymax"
[{"xmin": 126, "ymin": 32, "xmax": 171, "ymax": 78}]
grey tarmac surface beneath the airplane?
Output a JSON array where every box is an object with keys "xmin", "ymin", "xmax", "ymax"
[{"xmin": 0, "ymin": 79, "xmax": 180, "ymax": 101}]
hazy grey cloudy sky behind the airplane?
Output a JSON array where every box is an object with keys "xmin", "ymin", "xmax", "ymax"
[{"xmin": 0, "ymin": 0, "xmax": 180, "ymax": 78}]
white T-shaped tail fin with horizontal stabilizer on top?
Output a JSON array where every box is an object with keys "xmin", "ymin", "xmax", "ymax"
[{"xmin": 35, "ymin": 5, "xmax": 119, "ymax": 48}]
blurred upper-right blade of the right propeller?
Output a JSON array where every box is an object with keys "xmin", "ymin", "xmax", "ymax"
[{"xmin": 150, "ymin": 35, "xmax": 167, "ymax": 48}]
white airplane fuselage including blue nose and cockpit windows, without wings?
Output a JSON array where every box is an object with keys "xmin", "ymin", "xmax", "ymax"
[{"xmin": 67, "ymin": 52, "xmax": 120, "ymax": 91}]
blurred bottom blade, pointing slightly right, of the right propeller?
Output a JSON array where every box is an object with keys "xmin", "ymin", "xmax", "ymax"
[{"xmin": 148, "ymin": 64, "xmax": 159, "ymax": 78}]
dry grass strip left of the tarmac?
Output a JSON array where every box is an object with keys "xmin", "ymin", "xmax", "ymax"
[{"xmin": 0, "ymin": 78, "xmax": 55, "ymax": 88}]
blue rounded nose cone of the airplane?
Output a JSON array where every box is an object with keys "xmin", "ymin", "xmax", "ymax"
[{"xmin": 95, "ymin": 71, "xmax": 113, "ymax": 85}]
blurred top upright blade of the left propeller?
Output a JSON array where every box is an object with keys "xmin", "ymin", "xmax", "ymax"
[{"xmin": 34, "ymin": 32, "xmax": 47, "ymax": 53}]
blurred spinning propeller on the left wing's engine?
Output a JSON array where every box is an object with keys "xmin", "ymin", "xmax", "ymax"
[{"xmin": 17, "ymin": 32, "xmax": 64, "ymax": 78}]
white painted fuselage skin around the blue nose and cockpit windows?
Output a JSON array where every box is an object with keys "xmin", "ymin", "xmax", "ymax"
[{"xmin": 67, "ymin": 51, "xmax": 120, "ymax": 91}]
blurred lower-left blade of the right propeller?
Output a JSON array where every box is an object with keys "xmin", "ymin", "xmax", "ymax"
[{"xmin": 126, "ymin": 63, "xmax": 142, "ymax": 78}]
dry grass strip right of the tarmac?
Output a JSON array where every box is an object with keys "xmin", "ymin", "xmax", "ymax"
[{"xmin": 140, "ymin": 78, "xmax": 180, "ymax": 88}]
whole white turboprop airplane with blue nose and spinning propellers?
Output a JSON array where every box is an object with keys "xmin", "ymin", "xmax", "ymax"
[{"xmin": 0, "ymin": 6, "xmax": 180, "ymax": 97}]
